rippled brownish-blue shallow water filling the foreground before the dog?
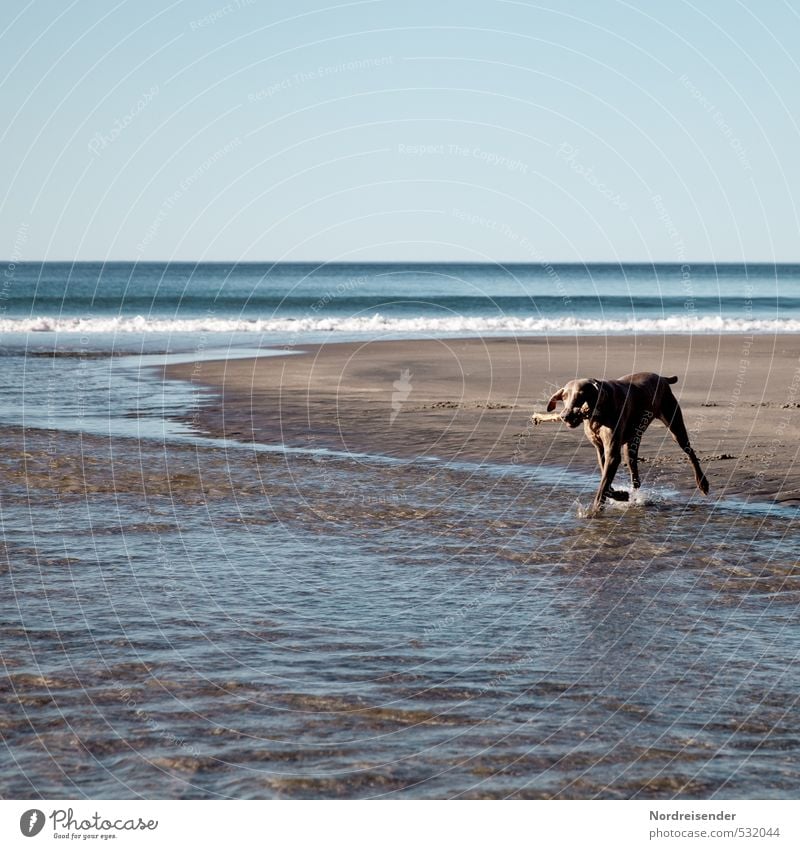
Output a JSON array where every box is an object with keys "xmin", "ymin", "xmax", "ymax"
[{"xmin": 0, "ymin": 429, "xmax": 800, "ymax": 798}]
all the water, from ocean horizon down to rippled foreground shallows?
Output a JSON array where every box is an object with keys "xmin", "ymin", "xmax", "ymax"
[{"xmin": 0, "ymin": 263, "xmax": 800, "ymax": 798}]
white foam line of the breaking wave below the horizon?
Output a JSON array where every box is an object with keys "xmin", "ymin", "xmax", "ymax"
[{"xmin": 0, "ymin": 314, "xmax": 800, "ymax": 335}]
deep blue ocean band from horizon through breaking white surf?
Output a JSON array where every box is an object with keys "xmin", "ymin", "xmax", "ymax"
[{"xmin": 0, "ymin": 263, "xmax": 800, "ymax": 346}]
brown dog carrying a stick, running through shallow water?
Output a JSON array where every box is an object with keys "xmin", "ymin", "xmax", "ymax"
[{"xmin": 544, "ymin": 372, "xmax": 708, "ymax": 508}]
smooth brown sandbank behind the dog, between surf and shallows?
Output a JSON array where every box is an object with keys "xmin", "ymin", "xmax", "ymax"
[{"xmin": 166, "ymin": 335, "xmax": 800, "ymax": 504}]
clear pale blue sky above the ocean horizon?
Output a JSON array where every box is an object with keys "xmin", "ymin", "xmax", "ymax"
[{"xmin": 0, "ymin": 0, "xmax": 800, "ymax": 263}]
